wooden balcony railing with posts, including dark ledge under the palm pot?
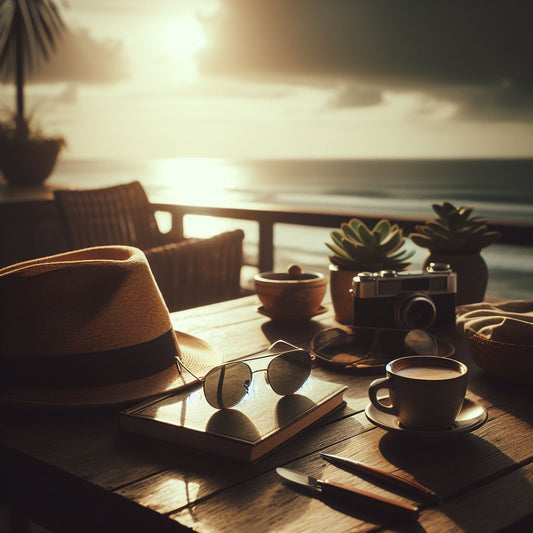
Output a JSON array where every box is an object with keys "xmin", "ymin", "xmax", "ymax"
[{"xmin": 0, "ymin": 199, "xmax": 533, "ymax": 272}]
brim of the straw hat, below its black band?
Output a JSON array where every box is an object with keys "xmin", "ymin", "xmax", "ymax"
[{"xmin": 1, "ymin": 331, "xmax": 222, "ymax": 409}]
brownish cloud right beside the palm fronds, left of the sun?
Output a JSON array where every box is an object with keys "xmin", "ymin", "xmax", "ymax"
[{"xmin": 31, "ymin": 28, "xmax": 129, "ymax": 85}]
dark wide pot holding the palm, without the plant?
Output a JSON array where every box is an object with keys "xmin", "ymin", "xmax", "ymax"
[{"xmin": 0, "ymin": 139, "xmax": 64, "ymax": 186}]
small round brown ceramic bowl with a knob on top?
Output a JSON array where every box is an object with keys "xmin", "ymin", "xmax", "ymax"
[{"xmin": 254, "ymin": 265, "xmax": 327, "ymax": 321}]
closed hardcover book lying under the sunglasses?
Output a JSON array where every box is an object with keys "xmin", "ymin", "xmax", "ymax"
[{"xmin": 120, "ymin": 377, "xmax": 346, "ymax": 462}]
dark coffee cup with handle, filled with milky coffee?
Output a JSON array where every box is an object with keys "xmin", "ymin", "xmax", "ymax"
[{"xmin": 368, "ymin": 355, "xmax": 468, "ymax": 430}]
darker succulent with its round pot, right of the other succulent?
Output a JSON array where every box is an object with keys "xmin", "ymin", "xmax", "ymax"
[{"xmin": 409, "ymin": 202, "xmax": 500, "ymax": 305}]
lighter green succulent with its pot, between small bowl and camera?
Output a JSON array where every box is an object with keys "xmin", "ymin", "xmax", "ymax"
[{"xmin": 326, "ymin": 218, "xmax": 414, "ymax": 324}]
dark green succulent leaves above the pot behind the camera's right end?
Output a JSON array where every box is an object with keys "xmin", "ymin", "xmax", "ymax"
[{"xmin": 409, "ymin": 202, "xmax": 500, "ymax": 253}]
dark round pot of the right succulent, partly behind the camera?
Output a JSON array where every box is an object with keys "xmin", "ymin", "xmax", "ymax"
[{"xmin": 424, "ymin": 252, "xmax": 489, "ymax": 305}]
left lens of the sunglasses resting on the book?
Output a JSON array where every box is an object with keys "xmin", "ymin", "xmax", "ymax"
[{"xmin": 204, "ymin": 363, "xmax": 252, "ymax": 409}]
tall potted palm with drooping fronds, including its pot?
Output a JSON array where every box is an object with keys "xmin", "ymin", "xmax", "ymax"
[{"xmin": 0, "ymin": 0, "xmax": 65, "ymax": 185}]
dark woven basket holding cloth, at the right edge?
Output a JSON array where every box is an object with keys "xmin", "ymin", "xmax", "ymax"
[{"xmin": 466, "ymin": 331, "xmax": 533, "ymax": 383}]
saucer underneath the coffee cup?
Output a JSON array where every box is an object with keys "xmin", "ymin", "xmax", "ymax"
[{"xmin": 365, "ymin": 399, "xmax": 489, "ymax": 437}]
